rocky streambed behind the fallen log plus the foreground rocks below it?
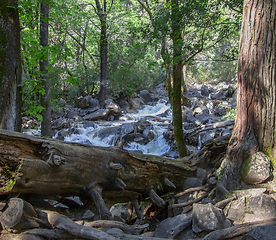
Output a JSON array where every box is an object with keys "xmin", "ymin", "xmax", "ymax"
[{"xmin": 12, "ymin": 82, "xmax": 276, "ymax": 240}]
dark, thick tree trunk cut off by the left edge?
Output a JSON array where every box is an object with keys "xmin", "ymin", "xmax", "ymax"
[{"xmin": 0, "ymin": 0, "xmax": 22, "ymax": 132}]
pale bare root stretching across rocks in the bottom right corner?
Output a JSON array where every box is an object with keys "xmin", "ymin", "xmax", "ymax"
[{"xmin": 203, "ymin": 218, "xmax": 276, "ymax": 240}]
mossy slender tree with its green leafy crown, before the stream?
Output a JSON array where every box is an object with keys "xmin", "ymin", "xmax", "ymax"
[{"xmin": 138, "ymin": 0, "xmax": 239, "ymax": 157}]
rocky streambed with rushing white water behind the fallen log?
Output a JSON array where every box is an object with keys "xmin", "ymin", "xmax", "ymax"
[{"xmin": 24, "ymin": 79, "xmax": 236, "ymax": 158}]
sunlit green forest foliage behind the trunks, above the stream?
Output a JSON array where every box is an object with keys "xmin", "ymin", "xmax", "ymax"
[{"xmin": 18, "ymin": 0, "xmax": 242, "ymax": 120}]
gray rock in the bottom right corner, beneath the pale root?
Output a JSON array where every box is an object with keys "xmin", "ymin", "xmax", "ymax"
[{"xmin": 242, "ymin": 225, "xmax": 276, "ymax": 240}]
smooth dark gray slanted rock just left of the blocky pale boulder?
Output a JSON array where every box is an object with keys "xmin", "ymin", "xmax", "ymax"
[{"xmin": 153, "ymin": 214, "xmax": 192, "ymax": 239}]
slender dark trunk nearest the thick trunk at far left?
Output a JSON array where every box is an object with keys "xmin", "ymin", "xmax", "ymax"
[{"xmin": 39, "ymin": 1, "xmax": 52, "ymax": 137}]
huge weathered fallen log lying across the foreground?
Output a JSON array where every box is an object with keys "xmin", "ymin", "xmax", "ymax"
[{"xmin": 0, "ymin": 130, "xmax": 196, "ymax": 204}]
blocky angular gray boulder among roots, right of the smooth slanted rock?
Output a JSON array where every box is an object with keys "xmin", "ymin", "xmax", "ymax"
[{"xmin": 192, "ymin": 203, "xmax": 231, "ymax": 233}]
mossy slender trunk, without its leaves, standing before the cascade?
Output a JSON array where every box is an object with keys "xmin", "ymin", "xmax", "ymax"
[{"xmin": 171, "ymin": 0, "xmax": 187, "ymax": 157}]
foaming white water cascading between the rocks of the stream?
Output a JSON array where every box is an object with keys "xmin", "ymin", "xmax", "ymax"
[{"xmin": 54, "ymin": 103, "xmax": 172, "ymax": 156}]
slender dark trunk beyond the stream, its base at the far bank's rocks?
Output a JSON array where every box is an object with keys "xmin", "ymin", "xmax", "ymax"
[{"xmin": 95, "ymin": 0, "xmax": 108, "ymax": 107}]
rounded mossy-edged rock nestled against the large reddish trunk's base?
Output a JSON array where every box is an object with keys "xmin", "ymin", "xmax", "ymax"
[{"xmin": 242, "ymin": 152, "xmax": 271, "ymax": 185}]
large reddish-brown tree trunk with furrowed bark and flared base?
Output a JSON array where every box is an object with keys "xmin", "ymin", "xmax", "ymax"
[{"xmin": 220, "ymin": 0, "xmax": 276, "ymax": 188}]
